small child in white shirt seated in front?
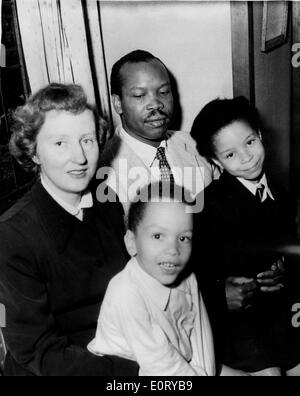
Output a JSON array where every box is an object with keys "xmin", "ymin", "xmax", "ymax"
[{"xmin": 88, "ymin": 184, "xmax": 245, "ymax": 376}]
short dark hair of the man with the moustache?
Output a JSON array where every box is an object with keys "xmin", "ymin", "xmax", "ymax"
[{"xmin": 110, "ymin": 50, "xmax": 168, "ymax": 96}]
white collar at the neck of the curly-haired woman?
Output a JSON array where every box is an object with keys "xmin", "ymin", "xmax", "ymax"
[{"xmin": 41, "ymin": 175, "xmax": 93, "ymax": 221}]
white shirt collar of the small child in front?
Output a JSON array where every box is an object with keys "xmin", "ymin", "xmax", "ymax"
[{"xmin": 128, "ymin": 258, "xmax": 190, "ymax": 311}]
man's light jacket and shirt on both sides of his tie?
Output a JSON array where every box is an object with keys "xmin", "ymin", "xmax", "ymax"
[{"xmin": 101, "ymin": 125, "xmax": 220, "ymax": 214}]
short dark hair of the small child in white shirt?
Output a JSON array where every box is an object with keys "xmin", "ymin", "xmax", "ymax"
[{"xmin": 127, "ymin": 182, "xmax": 195, "ymax": 232}]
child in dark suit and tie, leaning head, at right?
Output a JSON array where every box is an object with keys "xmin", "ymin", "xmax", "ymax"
[{"xmin": 192, "ymin": 97, "xmax": 300, "ymax": 375}]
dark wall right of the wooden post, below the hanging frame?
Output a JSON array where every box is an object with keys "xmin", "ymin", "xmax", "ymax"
[{"xmin": 253, "ymin": 2, "xmax": 292, "ymax": 188}]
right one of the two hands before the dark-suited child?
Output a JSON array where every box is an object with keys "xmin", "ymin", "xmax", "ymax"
[{"xmin": 257, "ymin": 257, "xmax": 285, "ymax": 293}]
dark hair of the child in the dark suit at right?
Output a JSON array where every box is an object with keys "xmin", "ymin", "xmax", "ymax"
[{"xmin": 191, "ymin": 96, "xmax": 260, "ymax": 160}]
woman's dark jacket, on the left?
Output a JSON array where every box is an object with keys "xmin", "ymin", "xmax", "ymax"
[{"xmin": 0, "ymin": 183, "xmax": 138, "ymax": 376}]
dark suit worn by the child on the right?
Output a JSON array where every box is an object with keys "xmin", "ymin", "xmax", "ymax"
[{"xmin": 197, "ymin": 172, "xmax": 295, "ymax": 370}]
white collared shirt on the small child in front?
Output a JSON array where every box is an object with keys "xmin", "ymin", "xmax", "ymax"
[{"xmin": 88, "ymin": 259, "xmax": 215, "ymax": 376}]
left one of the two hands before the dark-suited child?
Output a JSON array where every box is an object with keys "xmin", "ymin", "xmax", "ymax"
[{"xmin": 225, "ymin": 276, "xmax": 257, "ymax": 311}]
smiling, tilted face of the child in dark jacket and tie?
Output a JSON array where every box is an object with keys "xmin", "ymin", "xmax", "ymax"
[{"xmin": 214, "ymin": 121, "xmax": 265, "ymax": 181}]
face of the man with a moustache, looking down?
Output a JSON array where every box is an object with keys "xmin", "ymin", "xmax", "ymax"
[{"xmin": 113, "ymin": 60, "xmax": 173, "ymax": 147}]
